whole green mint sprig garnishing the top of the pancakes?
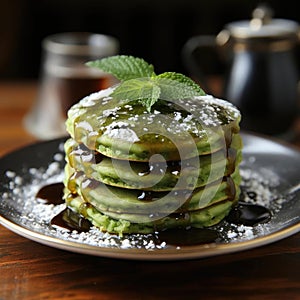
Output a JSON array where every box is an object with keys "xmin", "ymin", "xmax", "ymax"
[{"xmin": 87, "ymin": 55, "xmax": 205, "ymax": 112}]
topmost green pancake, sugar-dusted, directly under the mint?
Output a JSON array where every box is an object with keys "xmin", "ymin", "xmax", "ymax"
[{"xmin": 66, "ymin": 89, "xmax": 241, "ymax": 161}]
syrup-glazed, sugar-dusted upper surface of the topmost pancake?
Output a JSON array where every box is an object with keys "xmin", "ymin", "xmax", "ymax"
[{"xmin": 67, "ymin": 89, "xmax": 240, "ymax": 142}]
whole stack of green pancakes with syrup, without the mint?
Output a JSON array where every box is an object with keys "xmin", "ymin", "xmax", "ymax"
[{"xmin": 64, "ymin": 88, "xmax": 242, "ymax": 234}]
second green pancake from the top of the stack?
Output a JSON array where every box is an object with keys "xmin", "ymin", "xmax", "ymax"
[{"xmin": 65, "ymin": 135, "xmax": 241, "ymax": 191}]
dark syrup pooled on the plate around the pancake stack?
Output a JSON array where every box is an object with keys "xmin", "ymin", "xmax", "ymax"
[{"xmin": 36, "ymin": 183, "xmax": 271, "ymax": 246}]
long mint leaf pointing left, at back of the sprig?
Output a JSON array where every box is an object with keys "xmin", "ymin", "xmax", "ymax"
[{"xmin": 86, "ymin": 55, "xmax": 155, "ymax": 81}]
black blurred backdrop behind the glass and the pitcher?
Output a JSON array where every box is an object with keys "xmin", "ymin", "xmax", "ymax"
[{"xmin": 0, "ymin": 0, "xmax": 300, "ymax": 80}]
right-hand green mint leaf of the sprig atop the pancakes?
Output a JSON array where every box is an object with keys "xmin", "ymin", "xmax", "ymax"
[{"xmin": 155, "ymin": 72, "xmax": 205, "ymax": 100}]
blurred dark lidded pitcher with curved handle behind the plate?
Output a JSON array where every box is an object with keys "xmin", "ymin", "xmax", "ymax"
[{"xmin": 183, "ymin": 7, "xmax": 299, "ymax": 135}]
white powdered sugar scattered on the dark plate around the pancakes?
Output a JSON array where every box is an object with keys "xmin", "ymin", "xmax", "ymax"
[{"xmin": 0, "ymin": 145, "xmax": 298, "ymax": 250}]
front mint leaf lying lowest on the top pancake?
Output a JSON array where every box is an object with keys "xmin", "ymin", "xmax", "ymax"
[{"xmin": 111, "ymin": 78, "xmax": 160, "ymax": 111}]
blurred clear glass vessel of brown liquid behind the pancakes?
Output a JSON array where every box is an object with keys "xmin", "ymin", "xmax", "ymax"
[{"xmin": 25, "ymin": 32, "xmax": 119, "ymax": 139}]
